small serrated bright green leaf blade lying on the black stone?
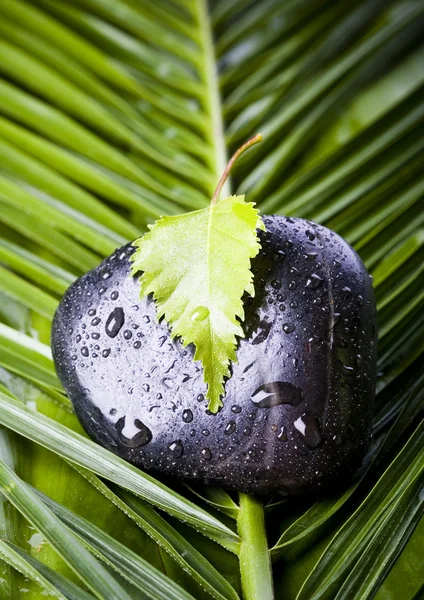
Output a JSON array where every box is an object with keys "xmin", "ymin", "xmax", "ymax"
[{"xmin": 131, "ymin": 196, "xmax": 264, "ymax": 413}]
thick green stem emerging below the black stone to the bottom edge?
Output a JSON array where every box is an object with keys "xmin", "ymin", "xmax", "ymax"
[{"xmin": 237, "ymin": 494, "xmax": 274, "ymax": 600}]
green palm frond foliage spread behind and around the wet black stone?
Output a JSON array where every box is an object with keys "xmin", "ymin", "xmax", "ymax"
[{"xmin": 0, "ymin": 0, "xmax": 424, "ymax": 600}]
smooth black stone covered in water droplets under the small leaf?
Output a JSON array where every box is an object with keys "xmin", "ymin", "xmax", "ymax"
[{"xmin": 52, "ymin": 217, "xmax": 376, "ymax": 495}]
